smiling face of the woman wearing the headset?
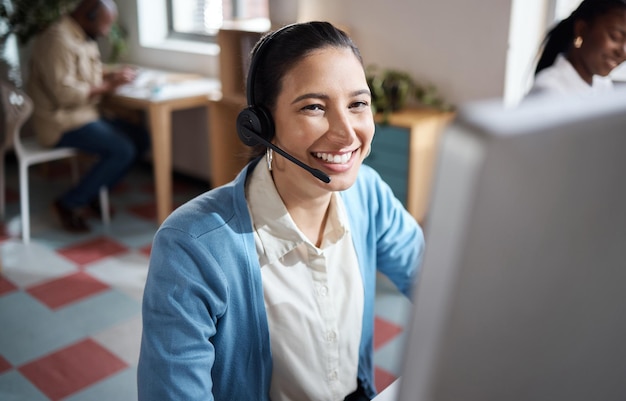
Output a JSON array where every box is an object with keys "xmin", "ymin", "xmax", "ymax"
[{"xmin": 272, "ymin": 47, "xmax": 375, "ymax": 196}]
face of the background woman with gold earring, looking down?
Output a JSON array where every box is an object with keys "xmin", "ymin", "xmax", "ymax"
[{"xmin": 574, "ymin": 9, "xmax": 626, "ymax": 82}]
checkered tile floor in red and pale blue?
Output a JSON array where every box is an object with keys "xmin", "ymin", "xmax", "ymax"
[{"xmin": 0, "ymin": 156, "xmax": 410, "ymax": 401}]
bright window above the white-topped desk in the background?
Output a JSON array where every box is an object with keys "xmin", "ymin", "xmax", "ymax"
[{"xmin": 167, "ymin": 0, "xmax": 268, "ymax": 39}]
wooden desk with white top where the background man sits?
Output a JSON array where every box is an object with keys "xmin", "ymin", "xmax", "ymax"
[{"xmin": 103, "ymin": 69, "xmax": 221, "ymax": 224}]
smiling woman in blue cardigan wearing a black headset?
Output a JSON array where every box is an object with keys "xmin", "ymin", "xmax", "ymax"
[{"xmin": 138, "ymin": 22, "xmax": 424, "ymax": 401}]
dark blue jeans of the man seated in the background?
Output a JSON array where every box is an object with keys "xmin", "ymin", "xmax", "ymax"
[{"xmin": 56, "ymin": 119, "xmax": 150, "ymax": 209}]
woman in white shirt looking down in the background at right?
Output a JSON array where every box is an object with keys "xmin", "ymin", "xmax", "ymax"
[{"xmin": 530, "ymin": 0, "xmax": 626, "ymax": 94}]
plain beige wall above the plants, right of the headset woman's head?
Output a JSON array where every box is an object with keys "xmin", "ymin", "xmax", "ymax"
[{"xmin": 302, "ymin": 0, "xmax": 511, "ymax": 103}]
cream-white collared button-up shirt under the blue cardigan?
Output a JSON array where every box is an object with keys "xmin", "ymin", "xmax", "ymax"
[{"xmin": 246, "ymin": 162, "xmax": 364, "ymax": 401}]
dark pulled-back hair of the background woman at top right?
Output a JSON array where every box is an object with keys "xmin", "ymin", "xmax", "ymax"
[{"xmin": 535, "ymin": 0, "xmax": 626, "ymax": 75}]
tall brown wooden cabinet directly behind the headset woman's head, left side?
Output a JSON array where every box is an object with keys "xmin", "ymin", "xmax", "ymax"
[{"xmin": 209, "ymin": 20, "xmax": 270, "ymax": 187}]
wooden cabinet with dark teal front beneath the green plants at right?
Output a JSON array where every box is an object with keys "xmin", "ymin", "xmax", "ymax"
[{"xmin": 365, "ymin": 109, "xmax": 454, "ymax": 223}]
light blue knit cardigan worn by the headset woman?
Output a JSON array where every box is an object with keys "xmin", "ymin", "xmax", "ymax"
[{"xmin": 137, "ymin": 162, "xmax": 424, "ymax": 401}]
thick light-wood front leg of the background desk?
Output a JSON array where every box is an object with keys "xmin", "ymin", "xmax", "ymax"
[{"xmin": 148, "ymin": 104, "xmax": 173, "ymax": 224}]
